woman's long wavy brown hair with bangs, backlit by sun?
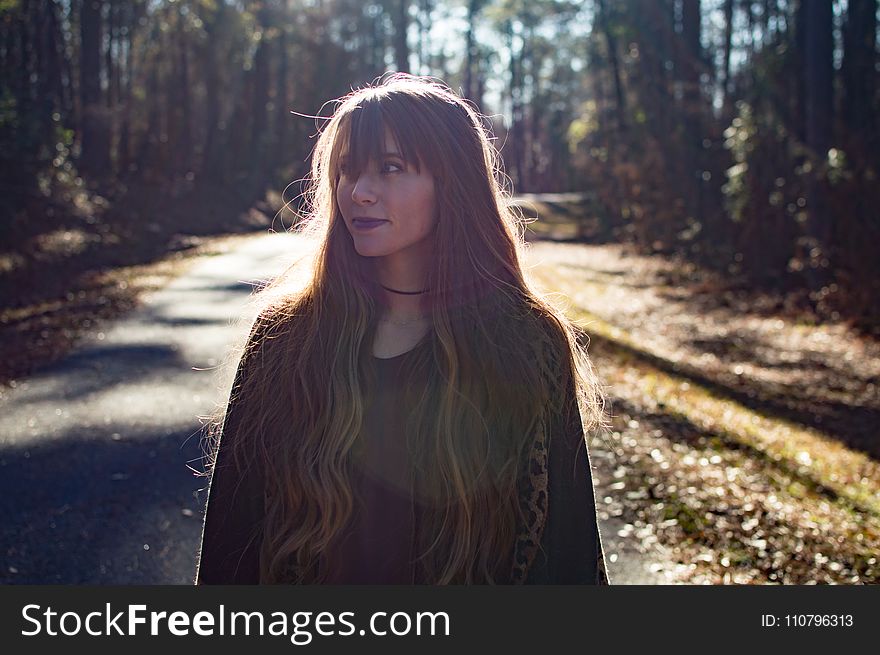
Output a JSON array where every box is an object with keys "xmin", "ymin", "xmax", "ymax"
[{"xmin": 211, "ymin": 74, "xmax": 604, "ymax": 584}]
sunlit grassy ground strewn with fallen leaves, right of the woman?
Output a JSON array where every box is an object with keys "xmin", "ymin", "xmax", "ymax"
[{"xmin": 530, "ymin": 241, "xmax": 880, "ymax": 584}]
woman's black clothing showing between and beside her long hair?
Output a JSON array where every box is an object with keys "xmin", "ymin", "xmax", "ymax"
[{"xmin": 196, "ymin": 318, "xmax": 608, "ymax": 584}]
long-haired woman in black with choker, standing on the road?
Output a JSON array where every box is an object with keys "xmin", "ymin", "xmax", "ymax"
[{"xmin": 196, "ymin": 74, "xmax": 607, "ymax": 584}]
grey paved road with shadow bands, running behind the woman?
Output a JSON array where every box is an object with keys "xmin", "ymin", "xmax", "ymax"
[{"xmin": 0, "ymin": 234, "xmax": 653, "ymax": 584}]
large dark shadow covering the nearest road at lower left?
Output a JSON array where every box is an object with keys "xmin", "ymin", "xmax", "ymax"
[{"xmin": 0, "ymin": 426, "xmax": 207, "ymax": 584}]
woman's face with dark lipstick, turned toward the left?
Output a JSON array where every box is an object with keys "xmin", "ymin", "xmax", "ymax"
[{"xmin": 336, "ymin": 130, "xmax": 437, "ymax": 257}]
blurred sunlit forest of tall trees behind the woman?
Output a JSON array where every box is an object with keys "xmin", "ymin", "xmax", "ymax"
[{"xmin": 0, "ymin": 0, "xmax": 880, "ymax": 344}]
